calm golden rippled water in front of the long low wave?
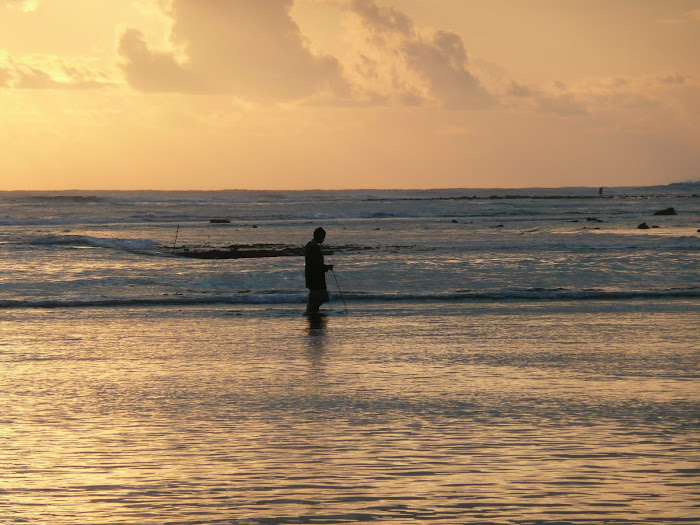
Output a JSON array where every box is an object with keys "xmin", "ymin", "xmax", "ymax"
[{"xmin": 0, "ymin": 303, "xmax": 700, "ymax": 525}]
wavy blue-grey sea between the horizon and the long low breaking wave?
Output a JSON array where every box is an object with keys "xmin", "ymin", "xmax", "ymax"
[{"xmin": 0, "ymin": 183, "xmax": 700, "ymax": 308}]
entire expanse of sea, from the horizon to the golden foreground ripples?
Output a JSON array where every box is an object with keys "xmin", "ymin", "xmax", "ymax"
[{"xmin": 0, "ymin": 184, "xmax": 700, "ymax": 525}]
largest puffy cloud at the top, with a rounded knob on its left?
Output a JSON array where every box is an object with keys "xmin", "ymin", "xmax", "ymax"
[{"xmin": 119, "ymin": 0, "xmax": 349, "ymax": 100}]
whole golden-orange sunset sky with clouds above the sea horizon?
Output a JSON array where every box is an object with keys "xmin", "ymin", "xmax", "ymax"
[{"xmin": 0, "ymin": 0, "xmax": 700, "ymax": 190}]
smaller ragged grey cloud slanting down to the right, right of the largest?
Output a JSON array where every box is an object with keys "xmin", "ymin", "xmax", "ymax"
[{"xmin": 348, "ymin": 0, "xmax": 495, "ymax": 109}]
